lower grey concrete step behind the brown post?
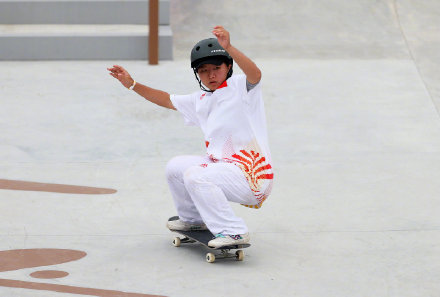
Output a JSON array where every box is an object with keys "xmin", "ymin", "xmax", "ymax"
[{"xmin": 0, "ymin": 25, "xmax": 173, "ymax": 60}]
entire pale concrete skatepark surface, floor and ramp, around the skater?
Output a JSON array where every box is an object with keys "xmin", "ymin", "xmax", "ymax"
[{"xmin": 0, "ymin": 0, "xmax": 440, "ymax": 297}]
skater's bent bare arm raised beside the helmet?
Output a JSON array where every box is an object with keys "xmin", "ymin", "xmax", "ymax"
[{"xmin": 212, "ymin": 26, "xmax": 261, "ymax": 85}]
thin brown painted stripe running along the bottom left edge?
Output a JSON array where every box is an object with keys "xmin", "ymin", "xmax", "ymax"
[{"xmin": 0, "ymin": 279, "xmax": 165, "ymax": 297}]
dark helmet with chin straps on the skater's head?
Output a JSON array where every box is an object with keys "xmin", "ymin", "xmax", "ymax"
[{"xmin": 191, "ymin": 38, "xmax": 233, "ymax": 92}]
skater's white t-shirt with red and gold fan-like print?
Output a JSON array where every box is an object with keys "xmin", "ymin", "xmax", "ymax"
[{"xmin": 171, "ymin": 75, "xmax": 273, "ymax": 208}]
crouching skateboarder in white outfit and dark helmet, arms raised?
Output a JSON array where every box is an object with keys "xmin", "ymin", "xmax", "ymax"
[{"xmin": 108, "ymin": 26, "xmax": 273, "ymax": 248}]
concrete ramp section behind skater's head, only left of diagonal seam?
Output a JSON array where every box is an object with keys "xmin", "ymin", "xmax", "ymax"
[{"xmin": 171, "ymin": 0, "xmax": 409, "ymax": 59}]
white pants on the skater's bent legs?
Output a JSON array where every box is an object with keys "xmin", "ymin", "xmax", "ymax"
[{"xmin": 166, "ymin": 156, "xmax": 258, "ymax": 235}]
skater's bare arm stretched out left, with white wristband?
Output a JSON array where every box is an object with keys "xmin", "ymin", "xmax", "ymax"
[{"xmin": 107, "ymin": 65, "xmax": 176, "ymax": 110}]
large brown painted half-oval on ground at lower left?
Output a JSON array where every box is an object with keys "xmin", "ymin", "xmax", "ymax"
[{"xmin": 0, "ymin": 249, "xmax": 87, "ymax": 272}]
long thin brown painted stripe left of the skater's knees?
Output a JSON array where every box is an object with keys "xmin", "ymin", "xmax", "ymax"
[{"xmin": 0, "ymin": 179, "xmax": 117, "ymax": 195}]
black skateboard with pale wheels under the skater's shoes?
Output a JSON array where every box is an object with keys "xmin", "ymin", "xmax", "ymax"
[{"xmin": 168, "ymin": 216, "xmax": 251, "ymax": 263}]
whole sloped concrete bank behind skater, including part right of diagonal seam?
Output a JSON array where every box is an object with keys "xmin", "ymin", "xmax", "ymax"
[{"xmin": 171, "ymin": 0, "xmax": 440, "ymax": 108}]
